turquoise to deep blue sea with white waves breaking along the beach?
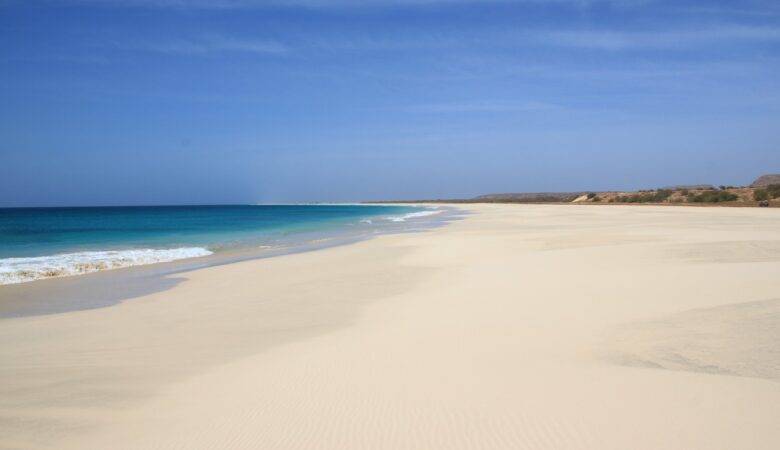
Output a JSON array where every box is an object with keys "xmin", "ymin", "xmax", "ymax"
[{"xmin": 0, "ymin": 205, "xmax": 440, "ymax": 284}]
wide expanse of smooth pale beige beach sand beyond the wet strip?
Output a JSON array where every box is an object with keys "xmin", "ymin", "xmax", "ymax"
[{"xmin": 0, "ymin": 205, "xmax": 780, "ymax": 449}]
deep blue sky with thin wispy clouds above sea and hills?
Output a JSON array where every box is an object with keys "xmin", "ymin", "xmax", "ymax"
[{"xmin": 0, "ymin": 0, "xmax": 780, "ymax": 206}]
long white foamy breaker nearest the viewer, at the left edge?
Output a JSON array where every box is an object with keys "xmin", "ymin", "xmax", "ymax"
[{"xmin": 0, "ymin": 247, "xmax": 212, "ymax": 285}]
